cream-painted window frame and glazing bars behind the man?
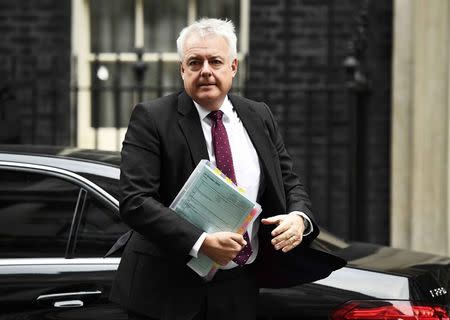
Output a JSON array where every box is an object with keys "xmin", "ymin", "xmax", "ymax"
[{"xmin": 71, "ymin": 0, "xmax": 250, "ymax": 150}]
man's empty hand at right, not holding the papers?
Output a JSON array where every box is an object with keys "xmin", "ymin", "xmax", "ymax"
[{"xmin": 261, "ymin": 214, "xmax": 305, "ymax": 252}]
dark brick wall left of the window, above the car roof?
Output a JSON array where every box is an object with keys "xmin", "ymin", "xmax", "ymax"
[{"xmin": 0, "ymin": 0, "xmax": 71, "ymax": 144}]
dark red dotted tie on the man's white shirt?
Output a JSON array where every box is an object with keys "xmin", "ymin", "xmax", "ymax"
[{"xmin": 208, "ymin": 110, "xmax": 253, "ymax": 266}]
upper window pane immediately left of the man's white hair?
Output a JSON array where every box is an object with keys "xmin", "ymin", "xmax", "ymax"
[{"xmin": 144, "ymin": 0, "xmax": 188, "ymax": 52}]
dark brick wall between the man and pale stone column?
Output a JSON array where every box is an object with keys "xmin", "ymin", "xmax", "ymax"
[{"xmin": 247, "ymin": 0, "xmax": 392, "ymax": 243}]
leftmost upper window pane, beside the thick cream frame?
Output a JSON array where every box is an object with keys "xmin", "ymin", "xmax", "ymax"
[{"xmin": 90, "ymin": 0, "xmax": 135, "ymax": 52}]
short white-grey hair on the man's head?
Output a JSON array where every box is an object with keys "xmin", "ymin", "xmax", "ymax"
[{"xmin": 177, "ymin": 18, "xmax": 237, "ymax": 61}]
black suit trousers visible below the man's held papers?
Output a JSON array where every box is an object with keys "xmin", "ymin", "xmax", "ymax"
[{"xmin": 128, "ymin": 266, "xmax": 259, "ymax": 320}]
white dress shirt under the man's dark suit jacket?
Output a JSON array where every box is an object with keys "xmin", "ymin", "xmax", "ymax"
[{"xmin": 190, "ymin": 97, "xmax": 312, "ymax": 269}]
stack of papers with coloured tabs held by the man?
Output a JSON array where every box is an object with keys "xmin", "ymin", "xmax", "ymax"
[{"xmin": 170, "ymin": 160, "xmax": 261, "ymax": 278}]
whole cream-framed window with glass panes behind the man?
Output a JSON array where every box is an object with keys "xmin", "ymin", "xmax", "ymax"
[{"xmin": 72, "ymin": 0, "xmax": 250, "ymax": 150}]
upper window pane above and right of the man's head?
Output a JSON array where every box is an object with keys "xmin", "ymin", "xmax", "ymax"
[{"xmin": 197, "ymin": 0, "xmax": 240, "ymax": 51}]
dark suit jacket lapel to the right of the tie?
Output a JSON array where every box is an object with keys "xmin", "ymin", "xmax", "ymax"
[{"xmin": 229, "ymin": 95, "xmax": 283, "ymax": 205}]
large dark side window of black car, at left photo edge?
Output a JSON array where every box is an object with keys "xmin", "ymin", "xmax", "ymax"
[{"xmin": 0, "ymin": 169, "xmax": 80, "ymax": 258}]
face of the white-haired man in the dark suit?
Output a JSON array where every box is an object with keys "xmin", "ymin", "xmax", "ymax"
[{"xmin": 181, "ymin": 36, "xmax": 238, "ymax": 110}]
